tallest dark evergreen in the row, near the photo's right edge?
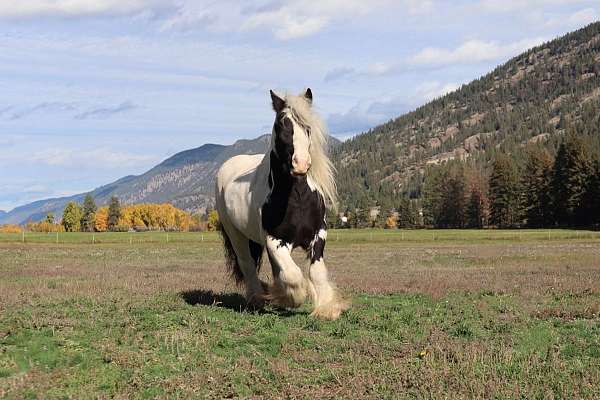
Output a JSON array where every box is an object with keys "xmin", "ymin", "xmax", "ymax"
[{"xmin": 552, "ymin": 131, "xmax": 592, "ymax": 226}]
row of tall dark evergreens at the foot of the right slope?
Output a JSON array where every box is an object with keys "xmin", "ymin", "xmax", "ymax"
[{"xmin": 422, "ymin": 130, "xmax": 600, "ymax": 228}]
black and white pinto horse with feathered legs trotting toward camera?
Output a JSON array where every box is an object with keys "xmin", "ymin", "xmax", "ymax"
[{"xmin": 216, "ymin": 89, "xmax": 348, "ymax": 319}]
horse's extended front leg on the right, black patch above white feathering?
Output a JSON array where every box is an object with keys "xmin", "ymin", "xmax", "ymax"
[{"xmin": 309, "ymin": 229, "xmax": 349, "ymax": 319}]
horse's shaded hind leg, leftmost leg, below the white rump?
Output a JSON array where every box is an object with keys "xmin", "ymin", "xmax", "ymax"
[{"xmin": 222, "ymin": 221, "xmax": 265, "ymax": 308}]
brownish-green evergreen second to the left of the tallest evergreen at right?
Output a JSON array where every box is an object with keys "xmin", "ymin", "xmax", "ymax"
[{"xmin": 489, "ymin": 153, "xmax": 521, "ymax": 228}]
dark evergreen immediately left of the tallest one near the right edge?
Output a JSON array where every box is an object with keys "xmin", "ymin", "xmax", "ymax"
[{"xmin": 522, "ymin": 147, "xmax": 552, "ymax": 228}]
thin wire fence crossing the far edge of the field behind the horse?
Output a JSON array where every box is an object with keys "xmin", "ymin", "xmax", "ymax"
[{"xmin": 0, "ymin": 229, "xmax": 600, "ymax": 245}]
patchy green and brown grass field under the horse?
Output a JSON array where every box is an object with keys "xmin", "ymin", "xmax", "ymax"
[{"xmin": 0, "ymin": 230, "xmax": 600, "ymax": 399}]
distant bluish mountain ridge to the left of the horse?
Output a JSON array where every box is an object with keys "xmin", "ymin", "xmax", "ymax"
[{"xmin": 0, "ymin": 135, "xmax": 270, "ymax": 224}]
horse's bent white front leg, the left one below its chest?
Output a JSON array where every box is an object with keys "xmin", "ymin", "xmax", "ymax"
[{"xmin": 267, "ymin": 236, "xmax": 306, "ymax": 308}]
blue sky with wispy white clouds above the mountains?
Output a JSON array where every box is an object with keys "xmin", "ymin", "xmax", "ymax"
[{"xmin": 0, "ymin": 0, "xmax": 600, "ymax": 210}]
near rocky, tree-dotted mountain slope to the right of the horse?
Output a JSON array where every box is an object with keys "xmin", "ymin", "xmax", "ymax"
[{"xmin": 333, "ymin": 22, "xmax": 600, "ymax": 208}]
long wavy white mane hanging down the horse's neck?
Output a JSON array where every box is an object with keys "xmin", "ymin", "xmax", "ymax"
[{"xmin": 284, "ymin": 94, "xmax": 337, "ymax": 210}]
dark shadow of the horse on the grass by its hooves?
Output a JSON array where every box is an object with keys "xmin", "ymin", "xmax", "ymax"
[{"xmin": 179, "ymin": 289, "xmax": 298, "ymax": 317}]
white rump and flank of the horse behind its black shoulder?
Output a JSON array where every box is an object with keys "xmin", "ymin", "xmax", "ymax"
[{"xmin": 215, "ymin": 154, "xmax": 268, "ymax": 242}]
